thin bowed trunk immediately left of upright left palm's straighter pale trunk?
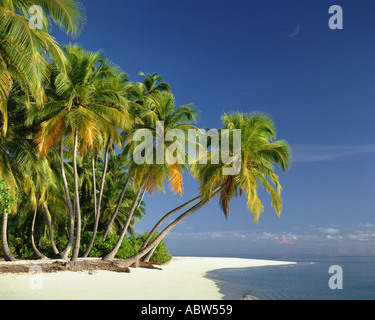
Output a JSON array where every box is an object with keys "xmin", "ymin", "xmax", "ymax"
[{"xmin": 56, "ymin": 138, "xmax": 74, "ymax": 259}]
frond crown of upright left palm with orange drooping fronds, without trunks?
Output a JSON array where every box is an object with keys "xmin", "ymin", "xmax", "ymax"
[{"xmin": 35, "ymin": 45, "xmax": 131, "ymax": 157}]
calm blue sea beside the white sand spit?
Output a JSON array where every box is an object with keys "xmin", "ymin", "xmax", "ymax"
[{"xmin": 207, "ymin": 255, "xmax": 375, "ymax": 300}]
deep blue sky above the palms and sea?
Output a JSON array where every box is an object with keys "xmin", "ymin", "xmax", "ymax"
[{"xmin": 53, "ymin": 0, "xmax": 375, "ymax": 255}]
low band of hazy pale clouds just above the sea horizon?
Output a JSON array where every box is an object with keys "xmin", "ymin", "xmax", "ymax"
[{"xmin": 166, "ymin": 223, "xmax": 375, "ymax": 255}]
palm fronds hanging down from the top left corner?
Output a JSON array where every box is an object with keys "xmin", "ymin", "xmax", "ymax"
[{"xmin": 0, "ymin": 0, "xmax": 85, "ymax": 134}]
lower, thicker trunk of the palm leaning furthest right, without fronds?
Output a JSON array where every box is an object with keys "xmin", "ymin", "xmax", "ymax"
[{"xmin": 120, "ymin": 188, "xmax": 222, "ymax": 267}]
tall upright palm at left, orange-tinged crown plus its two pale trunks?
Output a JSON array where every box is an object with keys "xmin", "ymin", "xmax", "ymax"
[{"xmin": 36, "ymin": 45, "xmax": 129, "ymax": 261}]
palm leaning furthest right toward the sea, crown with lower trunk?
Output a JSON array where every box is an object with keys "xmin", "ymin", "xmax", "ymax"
[{"xmin": 123, "ymin": 113, "xmax": 291, "ymax": 266}]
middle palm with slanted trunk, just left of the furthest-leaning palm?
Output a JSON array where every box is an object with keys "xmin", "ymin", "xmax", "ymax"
[{"xmin": 103, "ymin": 92, "xmax": 197, "ymax": 260}]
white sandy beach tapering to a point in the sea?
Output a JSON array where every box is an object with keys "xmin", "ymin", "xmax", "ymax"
[{"xmin": 0, "ymin": 257, "xmax": 293, "ymax": 300}]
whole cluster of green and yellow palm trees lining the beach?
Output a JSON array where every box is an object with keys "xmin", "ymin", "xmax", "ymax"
[{"xmin": 0, "ymin": 0, "xmax": 291, "ymax": 265}]
